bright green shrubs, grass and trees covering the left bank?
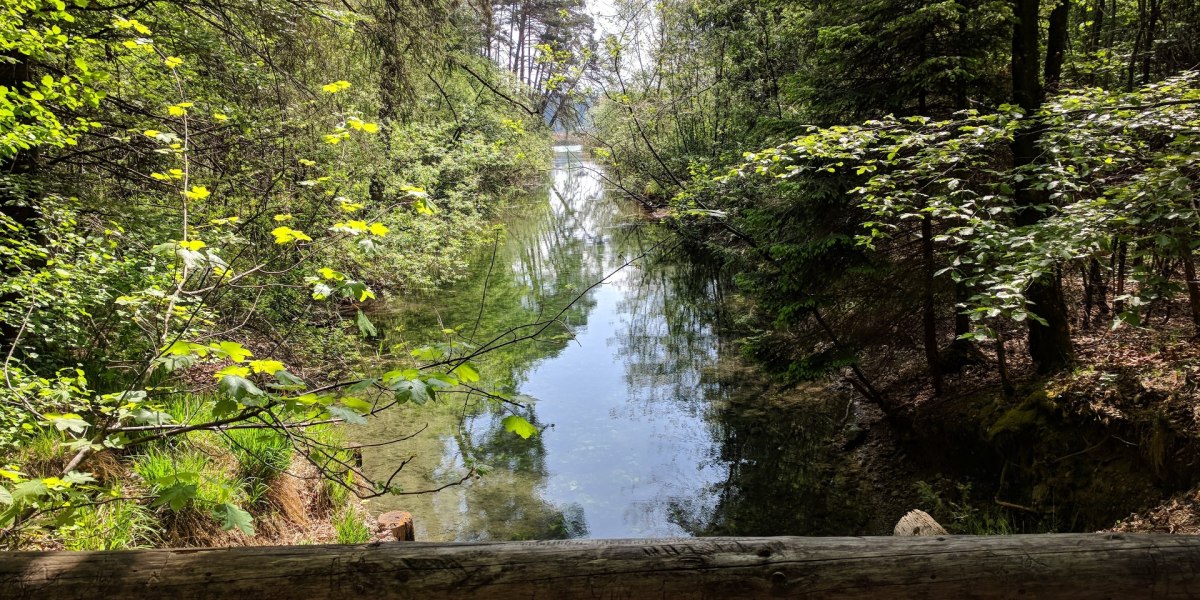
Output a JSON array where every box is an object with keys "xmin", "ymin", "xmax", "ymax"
[{"xmin": 0, "ymin": 0, "xmax": 587, "ymax": 550}]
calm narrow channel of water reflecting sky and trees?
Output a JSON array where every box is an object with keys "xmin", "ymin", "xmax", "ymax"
[{"xmin": 352, "ymin": 146, "xmax": 869, "ymax": 541}]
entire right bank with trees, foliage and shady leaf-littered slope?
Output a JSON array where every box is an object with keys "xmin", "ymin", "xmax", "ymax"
[{"xmin": 594, "ymin": 0, "xmax": 1200, "ymax": 530}]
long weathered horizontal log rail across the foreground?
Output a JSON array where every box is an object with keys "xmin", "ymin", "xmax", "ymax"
[{"xmin": 0, "ymin": 534, "xmax": 1200, "ymax": 600}]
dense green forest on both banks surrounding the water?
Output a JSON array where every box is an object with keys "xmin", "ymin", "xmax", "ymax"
[{"xmin": 7, "ymin": 0, "xmax": 1200, "ymax": 550}]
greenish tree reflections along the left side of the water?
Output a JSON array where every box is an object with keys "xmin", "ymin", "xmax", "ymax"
[{"xmin": 364, "ymin": 150, "xmax": 622, "ymax": 540}]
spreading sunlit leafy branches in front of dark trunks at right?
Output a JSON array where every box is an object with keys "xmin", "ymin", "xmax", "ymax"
[{"xmin": 737, "ymin": 73, "xmax": 1200, "ymax": 333}]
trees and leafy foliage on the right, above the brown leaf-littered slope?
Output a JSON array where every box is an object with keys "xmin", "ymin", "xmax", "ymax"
[{"xmin": 595, "ymin": 0, "xmax": 1200, "ymax": 400}]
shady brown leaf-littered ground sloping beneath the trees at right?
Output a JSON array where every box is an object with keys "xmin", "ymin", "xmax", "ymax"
[{"xmin": 848, "ymin": 319, "xmax": 1200, "ymax": 533}]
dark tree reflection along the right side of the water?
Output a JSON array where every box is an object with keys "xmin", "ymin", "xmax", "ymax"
[{"xmin": 616, "ymin": 246, "xmax": 866, "ymax": 535}]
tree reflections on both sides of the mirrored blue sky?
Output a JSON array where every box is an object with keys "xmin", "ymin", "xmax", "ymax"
[{"xmin": 374, "ymin": 148, "xmax": 864, "ymax": 540}]
